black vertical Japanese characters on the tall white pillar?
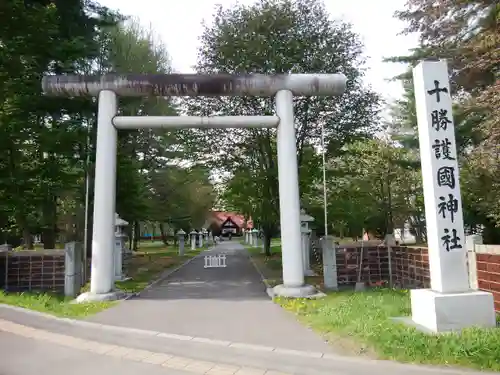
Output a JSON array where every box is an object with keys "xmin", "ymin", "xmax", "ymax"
[{"xmin": 427, "ymin": 79, "xmax": 462, "ymax": 252}]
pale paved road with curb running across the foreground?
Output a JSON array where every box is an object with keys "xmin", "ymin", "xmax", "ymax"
[{"xmin": 0, "ymin": 305, "xmax": 484, "ymax": 375}]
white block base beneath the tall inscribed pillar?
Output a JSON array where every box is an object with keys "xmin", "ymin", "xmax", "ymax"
[{"xmin": 411, "ymin": 289, "xmax": 496, "ymax": 333}]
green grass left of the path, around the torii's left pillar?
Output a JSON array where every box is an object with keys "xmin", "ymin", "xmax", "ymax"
[{"xmin": 0, "ymin": 242, "xmax": 203, "ymax": 318}]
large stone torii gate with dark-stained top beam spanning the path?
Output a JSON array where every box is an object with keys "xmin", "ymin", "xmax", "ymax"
[{"xmin": 42, "ymin": 74, "xmax": 346, "ymax": 302}]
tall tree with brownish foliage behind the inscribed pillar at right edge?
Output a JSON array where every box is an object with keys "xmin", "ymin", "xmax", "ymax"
[{"xmin": 389, "ymin": 0, "xmax": 500, "ymax": 241}]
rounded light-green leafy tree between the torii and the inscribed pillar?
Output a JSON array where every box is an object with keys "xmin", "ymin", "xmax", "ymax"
[{"xmin": 308, "ymin": 139, "xmax": 423, "ymax": 237}]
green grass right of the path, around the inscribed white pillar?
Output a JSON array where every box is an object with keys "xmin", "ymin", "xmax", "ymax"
[{"xmin": 248, "ymin": 239, "xmax": 500, "ymax": 371}]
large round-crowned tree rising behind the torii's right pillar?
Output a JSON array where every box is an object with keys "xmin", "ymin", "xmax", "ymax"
[{"xmin": 183, "ymin": 0, "xmax": 379, "ymax": 256}]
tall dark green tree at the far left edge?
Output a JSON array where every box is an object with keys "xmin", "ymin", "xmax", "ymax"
[{"xmin": 0, "ymin": 0, "xmax": 116, "ymax": 247}]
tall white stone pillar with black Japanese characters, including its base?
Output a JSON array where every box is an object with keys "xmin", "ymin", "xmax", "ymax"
[{"xmin": 411, "ymin": 61, "xmax": 496, "ymax": 332}]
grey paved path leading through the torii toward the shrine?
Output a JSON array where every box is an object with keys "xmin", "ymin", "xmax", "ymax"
[{"xmin": 89, "ymin": 241, "xmax": 332, "ymax": 353}]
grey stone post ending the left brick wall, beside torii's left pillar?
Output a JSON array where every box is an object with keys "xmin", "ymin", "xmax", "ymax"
[{"xmin": 64, "ymin": 242, "xmax": 83, "ymax": 297}]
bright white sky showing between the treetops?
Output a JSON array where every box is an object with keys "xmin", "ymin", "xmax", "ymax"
[{"xmin": 99, "ymin": 0, "xmax": 417, "ymax": 111}]
